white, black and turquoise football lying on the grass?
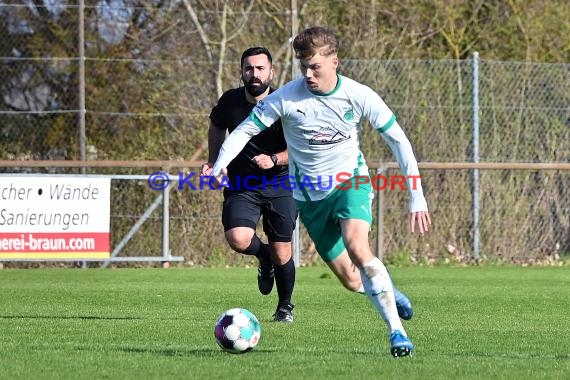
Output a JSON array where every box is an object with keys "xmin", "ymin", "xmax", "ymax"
[{"xmin": 214, "ymin": 308, "xmax": 261, "ymax": 354}]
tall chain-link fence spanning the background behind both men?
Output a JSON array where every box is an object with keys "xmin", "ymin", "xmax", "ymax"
[{"xmin": 0, "ymin": 2, "xmax": 570, "ymax": 263}]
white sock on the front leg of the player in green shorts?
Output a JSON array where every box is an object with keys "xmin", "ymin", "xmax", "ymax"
[{"xmin": 360, "ymin": 257, "xmax": 407, "ymax": 336}]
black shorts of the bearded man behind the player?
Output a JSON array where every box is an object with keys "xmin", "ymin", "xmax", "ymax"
[{"xmin": 222, "ymin": 189, "xmax": 297, "ymax": 243}]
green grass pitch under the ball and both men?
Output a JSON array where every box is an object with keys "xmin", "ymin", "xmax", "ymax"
[{"xmin": 0, "ymin": 267, "xmax": 570, "ymax": 380}]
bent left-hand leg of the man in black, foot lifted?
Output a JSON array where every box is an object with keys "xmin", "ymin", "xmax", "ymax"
[{"xmin": 222, "ymin": 192, "xmax": 274, "ymax": 295}]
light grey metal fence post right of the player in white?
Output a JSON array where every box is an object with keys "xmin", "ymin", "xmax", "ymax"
[{"xmin": 472, "ymin": 52, "xmax": 480, "ymax": 260}]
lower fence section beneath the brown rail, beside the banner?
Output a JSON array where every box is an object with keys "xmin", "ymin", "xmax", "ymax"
[{"xmin": 0, "ymin": 161, "xmax": 570, "ymax": 266}]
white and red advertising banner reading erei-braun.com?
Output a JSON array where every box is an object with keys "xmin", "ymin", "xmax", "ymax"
[{"xmin": 0, "ymin": 176, "xmax": 111, "ymax": 260}]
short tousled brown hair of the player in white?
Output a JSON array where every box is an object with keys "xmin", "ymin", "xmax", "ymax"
[{"xmin": 293, "ymin": 26, "xmax": 340, "ymax": 59}]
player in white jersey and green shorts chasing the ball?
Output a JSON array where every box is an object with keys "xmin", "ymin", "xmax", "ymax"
[{"xmin": 212, "ymin": 27, "xmax": 431, "ymax": 357}]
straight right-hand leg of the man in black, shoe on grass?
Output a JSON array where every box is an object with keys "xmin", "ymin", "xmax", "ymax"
[{"xmin": 262, "ymin": 190, "xmax": 297, "ymax": 322}]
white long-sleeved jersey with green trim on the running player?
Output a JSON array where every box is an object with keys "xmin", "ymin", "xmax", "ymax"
[{"xmin": 213, "ymin": 75, "xmax": 427, "ymax": 212}]
